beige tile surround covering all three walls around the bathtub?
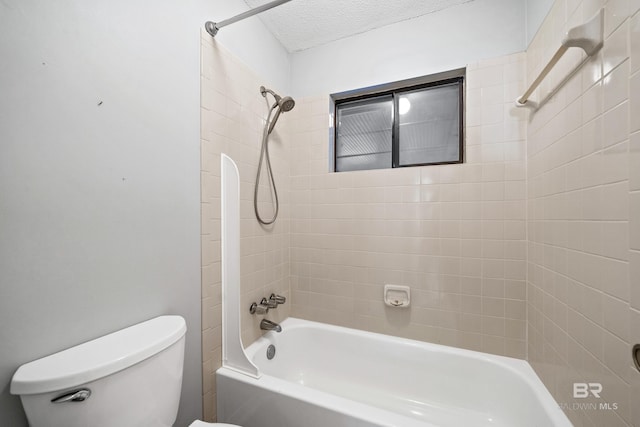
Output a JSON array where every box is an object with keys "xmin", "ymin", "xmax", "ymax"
[{"xmin": 202, "ymin": 0, "xmax": 640, "ymax": 427}]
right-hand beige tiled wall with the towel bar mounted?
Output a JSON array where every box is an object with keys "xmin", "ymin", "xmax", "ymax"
[{"xmin": 527, "ymin": 0, "xmax": 640, "ymax": 427}]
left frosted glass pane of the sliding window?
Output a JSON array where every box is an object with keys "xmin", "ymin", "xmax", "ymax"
[{"xmin": 336, "ymin": 95, "xmax": 393, "ymax": 172}]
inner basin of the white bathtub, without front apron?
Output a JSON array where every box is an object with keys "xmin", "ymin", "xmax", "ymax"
[{"xmin": 242, "ymin": 319, "xmax": 568, "ymax": 427}]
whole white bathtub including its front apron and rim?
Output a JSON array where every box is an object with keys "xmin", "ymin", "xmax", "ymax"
[{"xmin": 216, "ymin": 318, "xmax": 571, "ymax": 427}]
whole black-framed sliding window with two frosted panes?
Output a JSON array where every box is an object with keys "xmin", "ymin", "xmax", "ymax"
[{"xmin": 332, "ymin": 69, "xmax": 464, "ymax": 172}]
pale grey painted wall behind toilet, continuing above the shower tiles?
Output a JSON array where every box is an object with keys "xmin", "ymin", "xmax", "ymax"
[{"xmin": 0, "ymin": 0, "xmax": 289, "ymax": 427}]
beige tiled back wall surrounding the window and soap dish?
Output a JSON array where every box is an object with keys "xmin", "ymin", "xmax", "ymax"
[{"xmin": 291, "ymin": 54, "xmax": 526, "ymax": 358}]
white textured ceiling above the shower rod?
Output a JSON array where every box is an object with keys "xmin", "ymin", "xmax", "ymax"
[{"xmin": 244, "ymin": 0, "xmax": 473, "ymax": 52}]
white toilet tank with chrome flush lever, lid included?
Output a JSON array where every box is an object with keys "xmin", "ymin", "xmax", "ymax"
[{"xmin": 10, "ymin": 316, "xmax": 187, "ymax": 427}]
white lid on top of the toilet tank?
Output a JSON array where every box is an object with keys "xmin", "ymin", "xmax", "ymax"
[{"xmin": 10, "ymin": 316, "xmax": 187, "ymax": 395}]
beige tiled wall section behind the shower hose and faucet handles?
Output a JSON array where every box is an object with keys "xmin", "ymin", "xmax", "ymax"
[{"xmin": 201, "ymin": 33, "xmax": 290, "ymax": 421}]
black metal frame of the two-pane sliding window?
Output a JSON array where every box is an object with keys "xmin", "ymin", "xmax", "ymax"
[{"xmin": 330, "ymin": 68, "xmax": 466, "ymax": 172}]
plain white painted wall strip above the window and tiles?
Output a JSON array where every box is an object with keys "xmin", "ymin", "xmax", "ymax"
[{"xmin": 291, "ymin": 0, "xmax": 526, "ymax": 97}]
